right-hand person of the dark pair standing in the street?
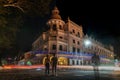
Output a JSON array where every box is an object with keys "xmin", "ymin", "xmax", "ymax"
[{"xmin": 51, "ymin": 54, "xmax": 58, "ymax": 76}]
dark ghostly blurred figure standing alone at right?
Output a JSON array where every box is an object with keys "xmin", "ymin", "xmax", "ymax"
[{"xmin": 91, "ymin": 54, "xmax": 100, "ymax": 80}]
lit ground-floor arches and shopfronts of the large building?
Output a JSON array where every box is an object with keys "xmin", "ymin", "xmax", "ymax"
[{"xmin": 22, "ymin": 53, "xmax": 114, "ymax": 65}]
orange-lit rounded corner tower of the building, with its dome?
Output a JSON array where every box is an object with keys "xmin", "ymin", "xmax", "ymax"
[{"xmin": 47, "ymin": 6, "xmax": 65, "ymax": 54}]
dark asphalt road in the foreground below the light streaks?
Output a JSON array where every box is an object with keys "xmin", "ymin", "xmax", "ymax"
[{"xmin": 0, "ymin": 69, "xmax": 120, "ymax": 80}]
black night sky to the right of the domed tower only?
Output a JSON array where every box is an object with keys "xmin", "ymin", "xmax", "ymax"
[{"xmin": 56, "ymin": 0, "xmax": 120, "ymax": 54}]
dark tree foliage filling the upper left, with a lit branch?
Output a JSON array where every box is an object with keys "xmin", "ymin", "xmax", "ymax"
[{"xmin": 0, "ymin": 0, "xmax": 52, "ymax": 57}]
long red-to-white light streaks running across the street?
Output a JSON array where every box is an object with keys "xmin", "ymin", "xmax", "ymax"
[{"xmin": 0, "ymin": 65, "xmax": 120, "ymax": 71}]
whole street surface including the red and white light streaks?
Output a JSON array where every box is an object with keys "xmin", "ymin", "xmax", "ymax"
[{"xmin": 0, "ymin": 65, "xmax": 120, "ymax": 80}]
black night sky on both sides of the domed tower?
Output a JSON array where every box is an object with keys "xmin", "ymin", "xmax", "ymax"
[{"xmin": 17, "ymin": 0, "xmax": 120, "ymax": 56}]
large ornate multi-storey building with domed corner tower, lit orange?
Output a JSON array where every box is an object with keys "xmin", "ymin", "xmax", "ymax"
[{"xmin": 32, "ymin": 7, "xmax": 114, "ymax": 65}]
